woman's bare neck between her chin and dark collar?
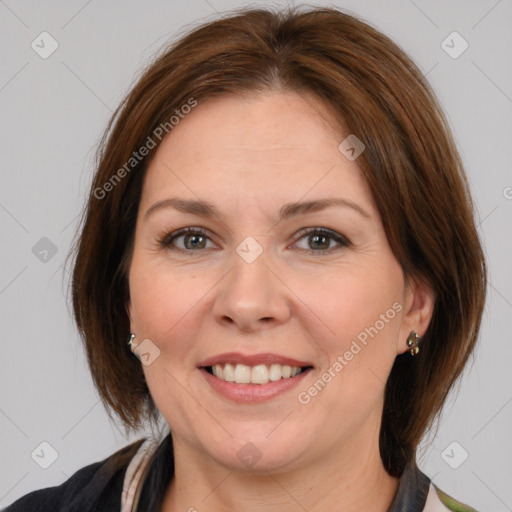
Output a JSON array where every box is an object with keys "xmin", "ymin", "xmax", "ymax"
[{"xmin": 162, "ymin": 432, "xmax": 399, "ymax": 512}]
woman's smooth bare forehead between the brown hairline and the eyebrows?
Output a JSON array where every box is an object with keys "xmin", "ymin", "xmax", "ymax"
[{"xmin": 143, "ymin": 92, "xmax": 372, "ymax": 216}]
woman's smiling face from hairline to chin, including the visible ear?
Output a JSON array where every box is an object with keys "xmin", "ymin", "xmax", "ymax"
[{"xmin": 128, "ymin": 92, "xmax": 430, "ymax": 471}]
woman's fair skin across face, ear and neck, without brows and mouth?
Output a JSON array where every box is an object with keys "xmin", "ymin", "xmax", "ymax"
[{"xmin": 127, "ymin": 91, "xmax": 434, "ymax": 512}]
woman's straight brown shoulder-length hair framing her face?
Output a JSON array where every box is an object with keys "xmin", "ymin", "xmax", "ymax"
[{"xmin": 72, "ymin": 4, "xmax": 486, "ymax": 476}]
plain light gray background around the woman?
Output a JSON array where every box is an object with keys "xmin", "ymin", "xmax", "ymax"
[{"xmin": 0, "ymin": 0, "xmax": 512, "ymax": 512}]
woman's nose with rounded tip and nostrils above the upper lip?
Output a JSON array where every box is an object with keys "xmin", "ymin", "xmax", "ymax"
[{"xmin": 213, "ymin": 246, "xmax": 291, "ymax": 332}]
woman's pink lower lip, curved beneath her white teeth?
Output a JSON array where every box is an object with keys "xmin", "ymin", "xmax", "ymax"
[{"xmin": 199, "ymin": 368, "xmax": 311, "ymax": 403}]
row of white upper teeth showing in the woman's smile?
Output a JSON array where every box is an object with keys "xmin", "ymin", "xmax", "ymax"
[{"xmin": 212, "ymin": 363, "xmax": 302, "ymax": 384}]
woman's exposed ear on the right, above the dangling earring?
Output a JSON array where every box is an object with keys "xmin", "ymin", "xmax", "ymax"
[{"xmin": 397, "ymin": 277, "xmax": 436, "ymax": 354}]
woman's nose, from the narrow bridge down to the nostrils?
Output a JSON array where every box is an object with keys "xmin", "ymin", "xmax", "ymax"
[{"xmin": 214, "ymin": 237, "xmax": 289, "ymax": 330}]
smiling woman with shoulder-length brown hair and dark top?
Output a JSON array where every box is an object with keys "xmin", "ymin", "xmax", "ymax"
[{"xmin": 7, "ymin": 5, "xmax": 486, "ymax": 512}]
